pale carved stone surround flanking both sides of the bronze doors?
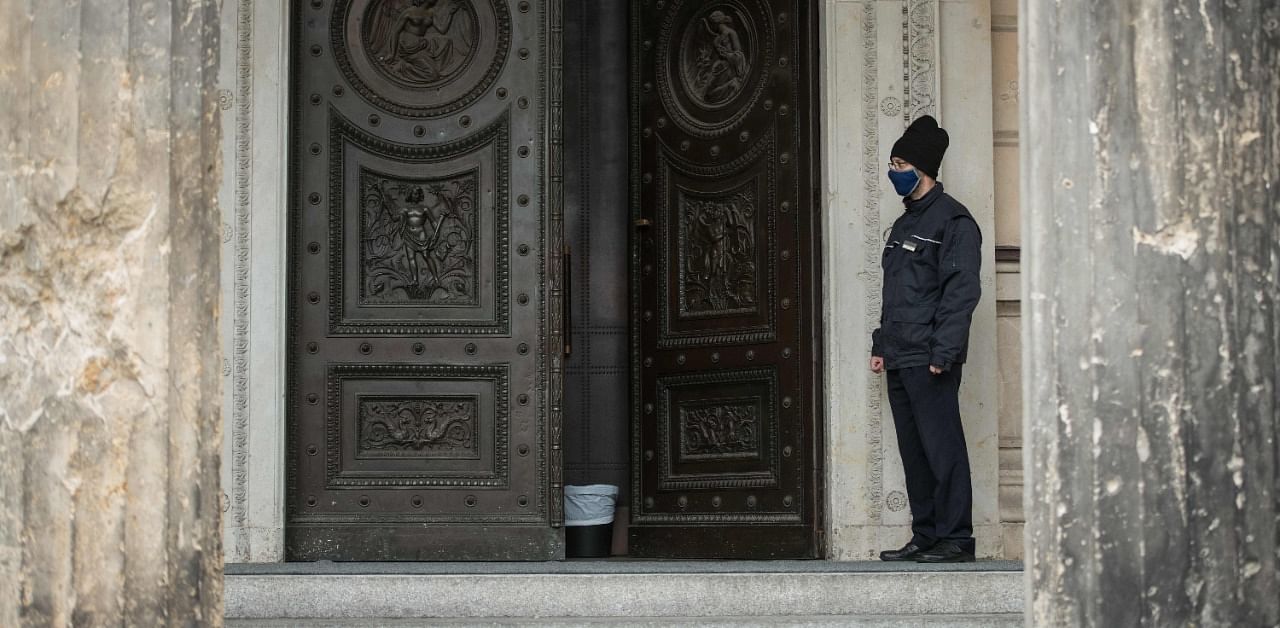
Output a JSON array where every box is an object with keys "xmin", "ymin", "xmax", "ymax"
[{"xmin": 219, "ymin": 0, "xmax": 1002, "ymax": 563}]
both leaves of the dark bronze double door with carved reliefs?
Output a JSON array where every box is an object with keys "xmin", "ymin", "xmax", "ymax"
[{"xmin": 285, "ymin": 0, "xmax": 820, "ymax": 560}]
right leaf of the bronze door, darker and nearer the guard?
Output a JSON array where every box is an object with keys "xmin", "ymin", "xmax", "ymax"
[{"xmin": 631, "ymin": 0, "xmax": 822, "ymax": 558}]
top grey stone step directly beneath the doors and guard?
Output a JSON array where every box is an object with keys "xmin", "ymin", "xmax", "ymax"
[{"xmin": 225, "ymin": 561, "xmax": 1024, "ymax": 625}]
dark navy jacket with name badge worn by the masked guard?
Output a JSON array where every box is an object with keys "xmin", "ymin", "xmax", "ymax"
[{"xmin": 872, "ymin": 183, "xmax": 982, "ymax": 370}]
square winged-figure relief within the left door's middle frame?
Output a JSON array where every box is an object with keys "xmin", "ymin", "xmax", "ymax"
[{"xmin": 360, "ymin": 170, "xmax": 477, "ymax": 306}]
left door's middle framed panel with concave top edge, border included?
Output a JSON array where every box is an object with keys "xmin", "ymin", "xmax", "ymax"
[{"xmin": 329, "ymin": 111, "xmax": 511, "ymax": 336}]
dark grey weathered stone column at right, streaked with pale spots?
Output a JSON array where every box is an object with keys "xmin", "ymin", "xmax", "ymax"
[{"xmin": 1021, "ymin": 0, "xmax": 1280, "ymax": 625}]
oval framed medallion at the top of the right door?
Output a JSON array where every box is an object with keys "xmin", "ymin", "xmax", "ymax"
[{"xmin": 658, "ymin": 0, "xmax": 773, "ymax": 137}]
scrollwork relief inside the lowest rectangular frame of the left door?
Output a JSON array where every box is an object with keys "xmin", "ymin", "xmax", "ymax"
[{"xmin": 358, "ymin": 398, "xmax": 476, "ymax": 455}]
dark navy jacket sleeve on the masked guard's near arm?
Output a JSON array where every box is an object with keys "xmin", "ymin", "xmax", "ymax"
[{"xmin": 929, "ymin": 216, "xmax": 982, "ymax": 371}]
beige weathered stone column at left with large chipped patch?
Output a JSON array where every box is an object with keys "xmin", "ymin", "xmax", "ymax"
[{"xmin": 0, "ymin": 0, "xmax": 221, "ymax": 627}]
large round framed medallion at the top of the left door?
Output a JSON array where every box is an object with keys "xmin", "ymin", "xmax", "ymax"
[{"xmin": 332, "ymin": 0, "xmax": 511, "ymax": 118}]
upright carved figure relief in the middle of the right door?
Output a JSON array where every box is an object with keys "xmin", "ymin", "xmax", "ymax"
[{"xmin": 680, "ymin": 191, "xmax": 756, "ymax": 315}]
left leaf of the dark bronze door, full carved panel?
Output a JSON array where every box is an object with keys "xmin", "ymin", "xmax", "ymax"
[{"xmin": 293, "ymin": 0, "xmax": 563, "ymax": 560}]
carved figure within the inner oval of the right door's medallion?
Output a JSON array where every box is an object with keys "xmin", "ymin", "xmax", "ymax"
[{"xmin": 680, "ymin": 5, "xmax": 753, "ymax": 109}]
